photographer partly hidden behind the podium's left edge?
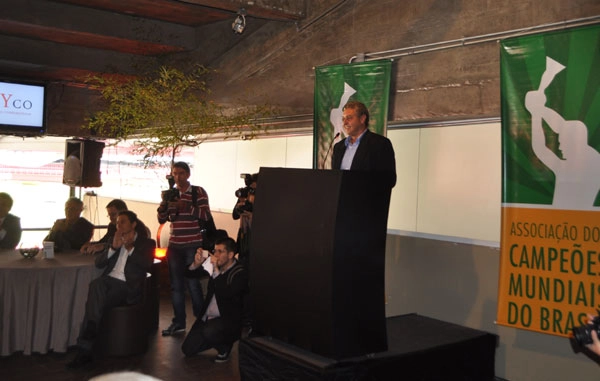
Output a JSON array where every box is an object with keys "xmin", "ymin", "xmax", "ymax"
[{"xmin": 232, "ymin": 173, "xmax": 258, "ymax": 267}]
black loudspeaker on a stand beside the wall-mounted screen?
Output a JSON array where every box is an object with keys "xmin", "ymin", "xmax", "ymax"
[{"xmin": 63, "ymin": 139, "xmax": 104, "ymax": 188}]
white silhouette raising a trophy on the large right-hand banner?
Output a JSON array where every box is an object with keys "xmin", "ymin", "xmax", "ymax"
[{"xmin": 525, "ymin": 57, "xmax": 600, "ymax": 210}]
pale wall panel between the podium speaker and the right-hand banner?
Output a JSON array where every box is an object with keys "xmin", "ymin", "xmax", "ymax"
[{"xmin": 388, "ymin": 123, "xmax": 501, "ymax": 246}]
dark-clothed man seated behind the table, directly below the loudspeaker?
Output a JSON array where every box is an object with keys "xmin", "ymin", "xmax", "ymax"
[{"xmin": 44, "ymin": 197, "xmax": 94, "ymax": 251}]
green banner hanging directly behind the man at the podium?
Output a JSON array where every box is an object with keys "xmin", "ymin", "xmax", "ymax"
[{"xmin": 313, "ymin": 60, "xmax": 392, "ymax": 168}]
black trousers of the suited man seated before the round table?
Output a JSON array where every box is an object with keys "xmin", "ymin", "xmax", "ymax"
[{"xmin": 77, "ymin": 275, "xmax": 128, "ymax": 350}]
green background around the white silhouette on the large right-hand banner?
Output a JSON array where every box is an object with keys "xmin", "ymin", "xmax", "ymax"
[{"xmin": 500, "ymin": 25, "xmax": 600, "ymax": 206}]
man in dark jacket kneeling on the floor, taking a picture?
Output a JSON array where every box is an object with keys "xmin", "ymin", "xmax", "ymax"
[{"xmin": 181, "ymin": 237, "xmax": 248, "ymax": 362}]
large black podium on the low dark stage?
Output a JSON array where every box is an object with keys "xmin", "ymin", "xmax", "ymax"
[{"xmin": 250, "ymin": 168, "xmax": 391, "ymax": 359}]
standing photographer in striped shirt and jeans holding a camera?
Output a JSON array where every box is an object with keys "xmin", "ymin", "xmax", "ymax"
[{"xmin": 157, "ymin": 162, "xmax": 211, "ymax": 336}]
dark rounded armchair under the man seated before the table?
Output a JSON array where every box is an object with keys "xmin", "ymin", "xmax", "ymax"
[{"xmin": 95, "ymin": 274, "xmax": 158, "ymax": 356}]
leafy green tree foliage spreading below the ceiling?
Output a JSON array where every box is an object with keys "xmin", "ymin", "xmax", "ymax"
[{"xmin": 84, "ymin": 65, "xmax": 276, "ymax": 160}]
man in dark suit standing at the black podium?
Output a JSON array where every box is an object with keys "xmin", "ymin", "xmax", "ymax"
[{"xmin": 331, "ymin": 101, "xmax": 396, "ymax": 188}]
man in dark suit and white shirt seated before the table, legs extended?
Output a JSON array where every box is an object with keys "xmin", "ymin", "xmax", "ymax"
[{"xmin": 67, "ymin": 210, "xmax": 156, "ymax": 368}]
